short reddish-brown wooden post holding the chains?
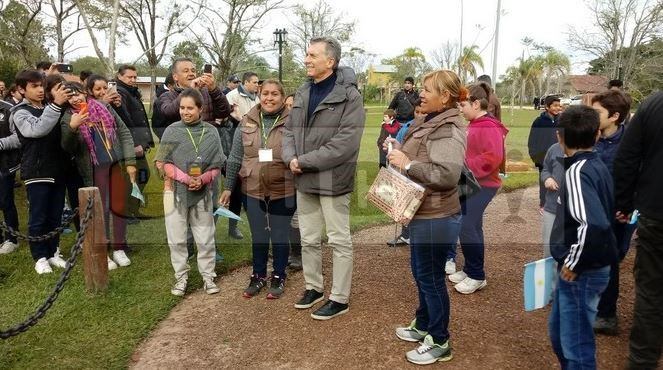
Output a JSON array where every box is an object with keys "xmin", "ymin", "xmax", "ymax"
[{"xmin": 78, "ymin": 187, "xmax": 108, "ymax": 293}]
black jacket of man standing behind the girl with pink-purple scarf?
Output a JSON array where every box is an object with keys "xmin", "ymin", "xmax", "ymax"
[{"xmin": 116, "ymin": 80, "xmax": 154, "ymax": 149}]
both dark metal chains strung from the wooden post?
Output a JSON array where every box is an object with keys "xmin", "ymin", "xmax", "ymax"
[{"xmin": 0, "ymin": 197, "xmax": 94, "ymax": 339}]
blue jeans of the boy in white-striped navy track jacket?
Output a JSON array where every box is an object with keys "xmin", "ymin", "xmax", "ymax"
[{"xmin": 548, "ymin": 266, "xmax": 610, "ymax": 370}]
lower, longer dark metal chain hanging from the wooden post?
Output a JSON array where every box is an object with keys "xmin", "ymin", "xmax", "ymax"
[{"xmin": 0, "ymin": 197, "xmax": 94, "ymax": 339}]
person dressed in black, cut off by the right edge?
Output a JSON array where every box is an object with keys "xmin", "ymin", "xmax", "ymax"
[{"xmin": 614, "ymin": 92, "xmax": 663, "ymax": 369}]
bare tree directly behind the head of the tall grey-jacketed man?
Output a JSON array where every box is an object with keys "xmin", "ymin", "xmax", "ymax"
[{"xmin": 290, "ymin": 0, "xmax": 356, "ymax": 61}]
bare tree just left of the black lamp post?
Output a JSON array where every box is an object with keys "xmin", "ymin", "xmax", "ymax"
[{"xmin": 193, "ymin": 0, "xmax": 284, "ymax": 76}]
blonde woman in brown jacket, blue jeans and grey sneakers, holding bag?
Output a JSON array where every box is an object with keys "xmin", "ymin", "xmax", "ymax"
[{"xmin": 385, "ymin": 70, "xmax": 468, "ymax": 365}]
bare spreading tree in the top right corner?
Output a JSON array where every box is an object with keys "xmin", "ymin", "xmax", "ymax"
[{"xmin": 569, "ymin": 0, "xmax": 663, "ymax": 83}]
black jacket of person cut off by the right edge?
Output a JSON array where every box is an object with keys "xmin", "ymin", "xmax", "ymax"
[{"xmin": 613, "ymin": 91, "xmax": 663, "ymax": 221}]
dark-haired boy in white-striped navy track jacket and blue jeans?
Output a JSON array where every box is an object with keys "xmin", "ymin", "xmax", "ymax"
[{"xmin": 549, "ymin": 106, "xmax": 617, "ymax": 369}]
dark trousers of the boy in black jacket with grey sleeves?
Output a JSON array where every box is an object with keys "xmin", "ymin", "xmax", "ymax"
[{"xmin": 25, "ymin": 182, "xmax": 65, "ymax": 261}]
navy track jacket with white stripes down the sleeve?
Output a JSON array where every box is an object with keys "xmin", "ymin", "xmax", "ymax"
[{"xmin": 550, "ymin": 152, "xmax": 617, "ymax": 274}]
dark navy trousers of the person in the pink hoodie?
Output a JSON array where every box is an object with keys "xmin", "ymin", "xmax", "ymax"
[{"xmin": 447, "ymin": 188, "xmax": 498, "ymax": 280}]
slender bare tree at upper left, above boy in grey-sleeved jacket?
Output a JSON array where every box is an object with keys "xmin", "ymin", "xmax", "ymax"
[{"xmin": 45, "ymin": 0, "xmax": 85, "ymax": 62}]
